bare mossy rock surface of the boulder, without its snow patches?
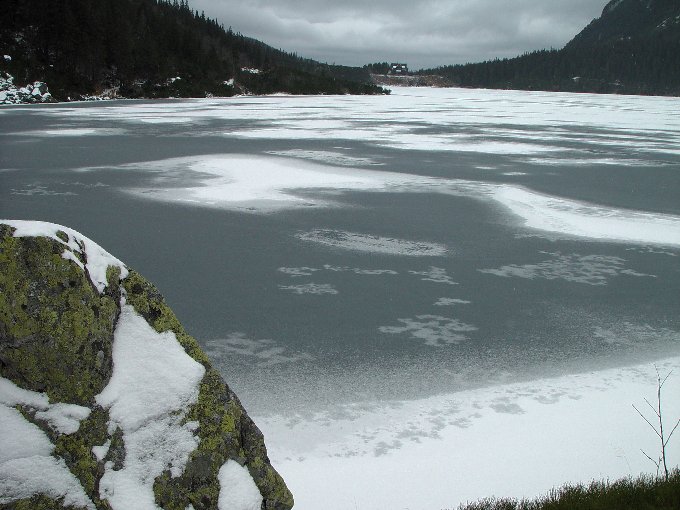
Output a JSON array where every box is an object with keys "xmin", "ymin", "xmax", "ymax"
[{"xmin": 0, "ymin": 224, "xmax": 293, "ymax": 510}]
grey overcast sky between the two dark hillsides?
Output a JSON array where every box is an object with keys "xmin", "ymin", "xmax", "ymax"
[{"xmin": 189, "ymin": 0, "xmax": 607, "ymax": 69}]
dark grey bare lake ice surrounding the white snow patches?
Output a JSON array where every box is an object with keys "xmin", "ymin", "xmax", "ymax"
[{"xmin": 0, "ymin": 89, "xmax": 680, "ymax": 413}]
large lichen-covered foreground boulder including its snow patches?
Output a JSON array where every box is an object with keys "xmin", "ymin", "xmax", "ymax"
[{"xmin": 0, "ymin": 221, "xmax": 293, "ymax": 510}]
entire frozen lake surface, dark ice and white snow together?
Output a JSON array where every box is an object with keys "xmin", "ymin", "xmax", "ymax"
[{"xmin": 0, "ymin": 88, "xmax": 680, "ymax": 510}]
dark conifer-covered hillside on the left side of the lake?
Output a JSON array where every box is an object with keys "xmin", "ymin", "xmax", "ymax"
[{"xmin": 0, "ymin": 0, "xmax": 384, "ymax": 100}]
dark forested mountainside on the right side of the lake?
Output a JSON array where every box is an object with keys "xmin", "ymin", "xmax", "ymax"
[{"xmin": 420, "ymin": 0, "xmax": 680, "ymax": 96}]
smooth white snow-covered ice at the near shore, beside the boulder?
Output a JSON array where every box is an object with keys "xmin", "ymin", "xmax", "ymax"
[{"xmin": 255, "ymin": 358, "xmax": 680, "ymax": 510}]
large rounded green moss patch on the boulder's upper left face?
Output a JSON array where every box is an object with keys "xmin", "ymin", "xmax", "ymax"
[{"xmin": 0, "ymin": 225, "xmax": 120, "ymax": 405}]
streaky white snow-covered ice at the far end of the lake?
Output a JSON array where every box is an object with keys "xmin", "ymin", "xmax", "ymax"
[{"xmin": 26, "ymin": 87, "xmax": 680, "ymax": 164}]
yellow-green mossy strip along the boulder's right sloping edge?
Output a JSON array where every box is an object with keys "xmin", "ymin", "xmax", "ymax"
[{"xmin": 123, "ymin": 270, "xmax": 293, "ymax": 510}]
